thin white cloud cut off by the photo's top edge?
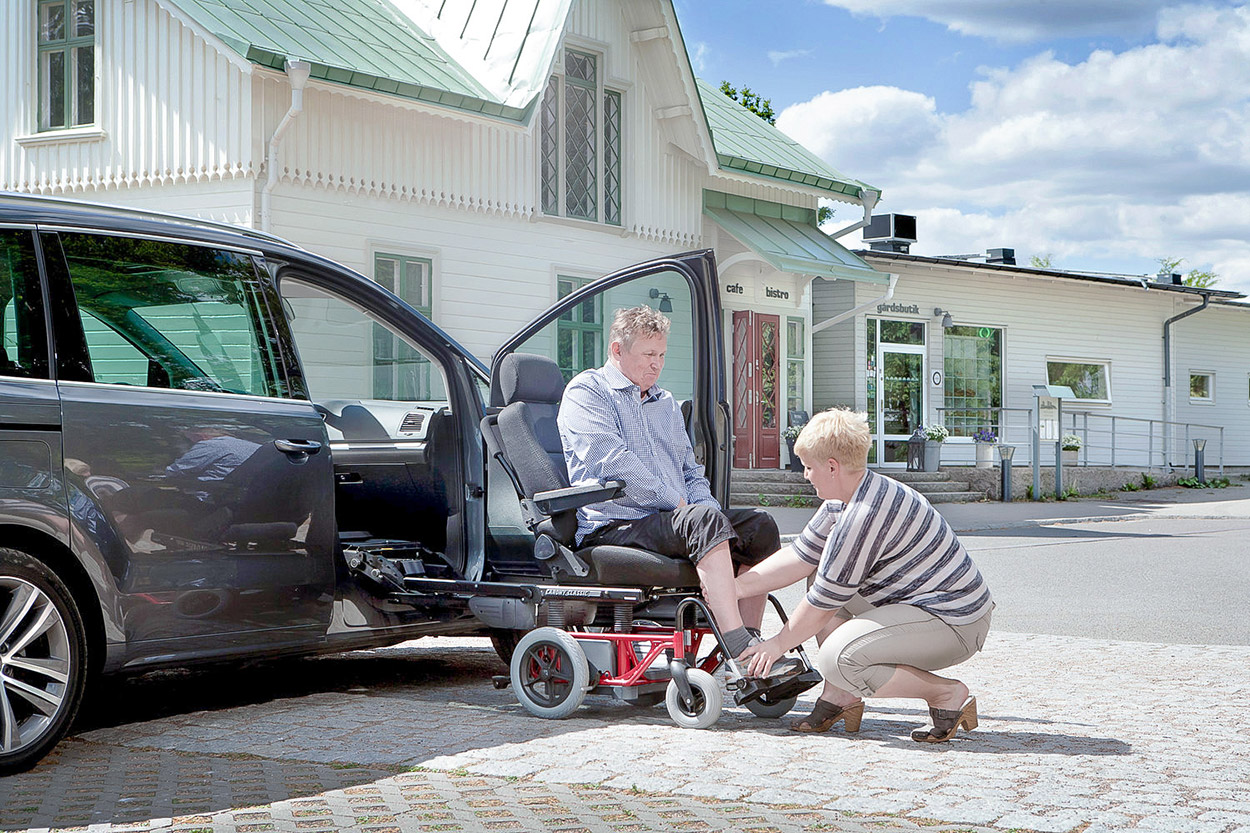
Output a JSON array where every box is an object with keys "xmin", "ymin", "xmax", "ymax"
[{"xmin": 825, "ymin": 0, "xmax": 1176, "ymax": 41}]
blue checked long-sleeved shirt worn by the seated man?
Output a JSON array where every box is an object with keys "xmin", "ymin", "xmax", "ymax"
[{"xmin": 558, "ymin": 364, "xmax": 720, "ymax": 543}]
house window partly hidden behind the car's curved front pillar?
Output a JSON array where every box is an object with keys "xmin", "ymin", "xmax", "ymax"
[{"xmin": 373, "ymin": 254, "xmax": 441, "ymax": 401}]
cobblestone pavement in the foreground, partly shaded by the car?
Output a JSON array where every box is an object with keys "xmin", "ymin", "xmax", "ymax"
[{"xmin": 0, "ymin": 633, "xmax": 1250, "ymax": 833}]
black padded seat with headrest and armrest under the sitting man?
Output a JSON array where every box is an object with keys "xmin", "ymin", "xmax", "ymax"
[{"xmin": 483, "ymin": 353, "xmax": 699, "ymax": 589}]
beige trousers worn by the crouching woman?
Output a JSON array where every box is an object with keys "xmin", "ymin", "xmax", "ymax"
[{"xmin": 816, "ymin": 595, "xmax": 990, "ymax": 697}]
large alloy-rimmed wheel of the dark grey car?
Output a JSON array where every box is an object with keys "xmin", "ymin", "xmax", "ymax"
[{"xmin": 0, "ymin": 548, "xmax": 86, "ymax": 775}]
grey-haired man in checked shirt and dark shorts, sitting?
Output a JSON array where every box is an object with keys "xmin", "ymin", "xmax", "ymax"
[{"xmin": 558, "ymin": 301, "xmax": 798, "ymax": 677}]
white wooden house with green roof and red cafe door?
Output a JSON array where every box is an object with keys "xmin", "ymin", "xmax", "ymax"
[{"xmin": 0, "ymin": 0, "xmax": 888, "ymax": 467}]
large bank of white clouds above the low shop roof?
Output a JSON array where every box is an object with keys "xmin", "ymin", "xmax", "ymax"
[{"xmin": 778, "ymin": 0, "xmax": 1250, "ymax": 293}]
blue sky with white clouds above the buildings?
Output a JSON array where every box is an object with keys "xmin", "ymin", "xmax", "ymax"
[{"xmin": 675, "ymin": 0, "xmax": 1250, "ymax": 294}]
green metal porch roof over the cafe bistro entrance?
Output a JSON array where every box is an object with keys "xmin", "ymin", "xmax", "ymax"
[{"xmin": 704, "ymin": 192, "xmax": 890, "ymax": 284}]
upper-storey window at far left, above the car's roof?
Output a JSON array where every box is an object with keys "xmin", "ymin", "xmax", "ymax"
[{"xmin": 36, "ymin": 0, "xmax": 95, "ymax": 130}]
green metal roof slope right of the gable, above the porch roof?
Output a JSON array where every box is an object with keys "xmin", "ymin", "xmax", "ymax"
[{"xmin": 696, "ymin": 79, "xmax": 878, "ymax": 199}]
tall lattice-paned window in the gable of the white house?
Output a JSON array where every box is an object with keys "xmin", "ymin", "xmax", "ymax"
[{"xmin": 539, "ymin": 49, "xmax": 623, "ymax": 225}]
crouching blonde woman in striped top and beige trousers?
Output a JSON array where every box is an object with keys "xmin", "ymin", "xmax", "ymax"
[{"xmin": 736, "ymin": 408, "xmax": 994, "ymax": 743}]
